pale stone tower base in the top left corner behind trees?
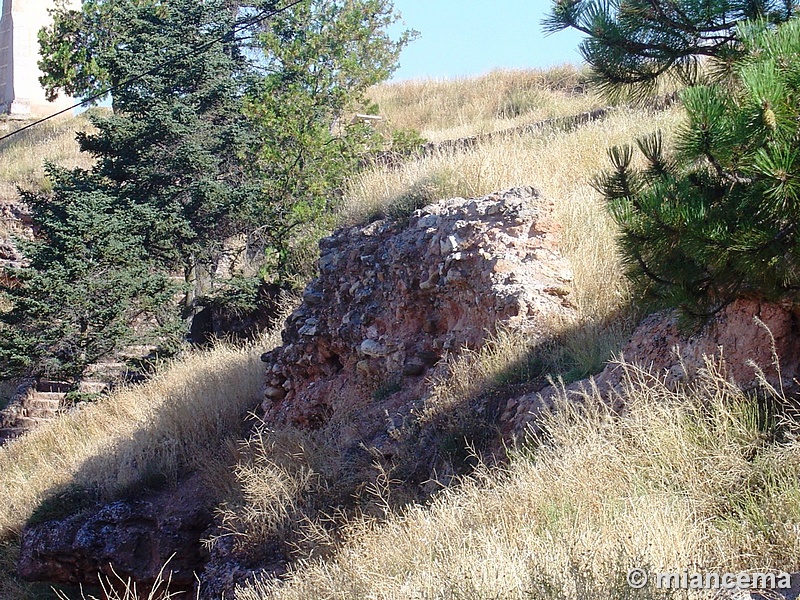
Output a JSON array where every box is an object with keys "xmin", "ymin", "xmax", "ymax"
[{"xmin": 0, "ymin": 0, "xmax": 81, "ymax": 119}]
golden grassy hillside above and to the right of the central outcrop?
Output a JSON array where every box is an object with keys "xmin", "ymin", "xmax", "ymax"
[{"xmin": 341, "ymin": 67, "xmax": 680, "ymax": 374}]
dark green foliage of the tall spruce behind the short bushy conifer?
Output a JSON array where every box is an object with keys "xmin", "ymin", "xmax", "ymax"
[{"xmin": 70, "ymin": 0, "xmax": 252, "ymax": 273}]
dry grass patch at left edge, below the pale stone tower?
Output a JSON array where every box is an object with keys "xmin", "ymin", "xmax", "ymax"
[{"xmin": 0, "ymin": 116, "xmax": 94, "ymax": 200}]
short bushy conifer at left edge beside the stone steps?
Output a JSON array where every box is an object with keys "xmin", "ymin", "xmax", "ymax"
[{"xmin": 0, "ymin": 167, "xmax": 176, "ymax": 377}]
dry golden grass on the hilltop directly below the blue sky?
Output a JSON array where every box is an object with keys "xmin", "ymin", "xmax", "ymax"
[{"xmin": 369, "ymin": 65, "xmax": 599, "ymax": 142}]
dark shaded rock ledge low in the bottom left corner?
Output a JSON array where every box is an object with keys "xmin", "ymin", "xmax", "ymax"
[{"xmin": 18, "ymin": 477, "xmax": 213, "ymax": 591}]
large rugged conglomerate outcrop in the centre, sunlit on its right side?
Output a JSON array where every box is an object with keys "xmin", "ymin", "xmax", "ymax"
[{"xmin": 262, "ymin": 188, "xmax": 574, "ymax": 443}]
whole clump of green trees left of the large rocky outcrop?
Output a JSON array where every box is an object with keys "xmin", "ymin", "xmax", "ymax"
[{"xmin": 0, "ymin": 0, "xmax": 409, "ymax": 375}]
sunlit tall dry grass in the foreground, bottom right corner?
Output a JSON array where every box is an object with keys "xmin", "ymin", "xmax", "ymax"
[{"xmin": 236, "ymin": 358, "xmax": 800, "ymax": 600}]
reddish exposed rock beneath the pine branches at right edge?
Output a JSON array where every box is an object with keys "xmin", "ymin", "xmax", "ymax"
[{"xmin": 501, "ymin": 299, "xmax": 800, "ymax": 434}]
